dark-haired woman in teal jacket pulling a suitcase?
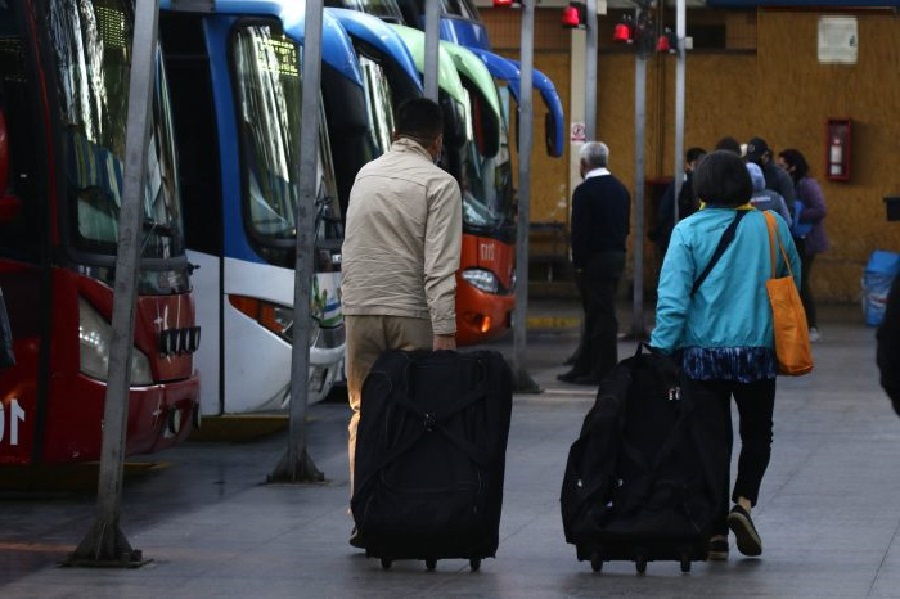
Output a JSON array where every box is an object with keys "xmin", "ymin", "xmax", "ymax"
[{"xmin": 650, "ymin": 151, "xmax": 800, "ymax": 559}]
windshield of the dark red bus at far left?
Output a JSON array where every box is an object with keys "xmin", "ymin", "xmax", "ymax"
[{"xmin": 47, "ymin": 0, "xmax": 184, "ymax": 258}]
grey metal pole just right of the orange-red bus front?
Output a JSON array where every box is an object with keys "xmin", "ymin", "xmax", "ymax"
[{"xmin": 513, "ymin": 0, "xmax": 540, "ymax": 393}]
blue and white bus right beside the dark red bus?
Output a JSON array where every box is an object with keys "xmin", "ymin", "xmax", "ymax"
[{"xmin": 160, "ymin": 0, "xmax": 360, "ymax": 415}]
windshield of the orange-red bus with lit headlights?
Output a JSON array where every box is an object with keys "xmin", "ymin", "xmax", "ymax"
[{"xmin": 460, "ymin": 94, "xmax": 513, "ymax": 229}]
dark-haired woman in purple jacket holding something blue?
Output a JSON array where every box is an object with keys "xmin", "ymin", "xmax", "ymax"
[{"xmin": 778, "ymin": 148, "xmax": 831, "ymax": 343}]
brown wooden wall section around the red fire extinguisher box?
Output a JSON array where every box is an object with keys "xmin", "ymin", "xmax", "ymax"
[{"xmin": 756, "ymin": 12, "xmax": 900, "ymax": 300}]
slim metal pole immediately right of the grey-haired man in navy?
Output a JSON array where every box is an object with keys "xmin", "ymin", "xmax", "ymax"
[{"xmin": 631, "ymin": 52, "xmax": 647, "ymax": 339}]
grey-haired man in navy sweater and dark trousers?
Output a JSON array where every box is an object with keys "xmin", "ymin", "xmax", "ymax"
[{"xmin": 557, "ymin": 141, "xmax": 631, "ymax": 385}]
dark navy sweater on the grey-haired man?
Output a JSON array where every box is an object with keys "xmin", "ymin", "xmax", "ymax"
[{"xmin": 572, "ymin": 175, "xmax": 631, "ymax": 268}]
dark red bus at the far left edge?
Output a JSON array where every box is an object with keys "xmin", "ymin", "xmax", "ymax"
[{"xmin": 0, "ymin": 0, "xmax": 200, "ymax": 464}]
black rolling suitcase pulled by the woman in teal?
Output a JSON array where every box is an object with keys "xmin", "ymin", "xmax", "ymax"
[{"xmin": 561, "ymin": 346, "xmax": 729, "ymax": 574}]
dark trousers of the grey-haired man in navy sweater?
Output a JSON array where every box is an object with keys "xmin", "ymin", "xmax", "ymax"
[{"xmin": 573, "ymin": 252, "xmax": 625, "ymax": 379}]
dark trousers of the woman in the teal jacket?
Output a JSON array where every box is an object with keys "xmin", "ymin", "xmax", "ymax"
[{"xmin": 683, "ymin": 379, "xmax": 775, "ymax": 535}]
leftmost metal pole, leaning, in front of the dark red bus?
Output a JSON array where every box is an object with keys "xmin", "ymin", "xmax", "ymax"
[{"xmin": 67, "ymin": 0, "xmax": 158, "ymax": 568}]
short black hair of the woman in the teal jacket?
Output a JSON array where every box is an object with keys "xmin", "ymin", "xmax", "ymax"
[{"xmin": 694, "ymin": 150, "xmax": 753, "ymax": 208}]
